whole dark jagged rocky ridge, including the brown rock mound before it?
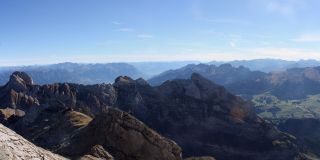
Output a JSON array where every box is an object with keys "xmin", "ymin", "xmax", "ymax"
[{"xmin": 0, "ymin": 74, "xmax": 310, "ymax": 160}]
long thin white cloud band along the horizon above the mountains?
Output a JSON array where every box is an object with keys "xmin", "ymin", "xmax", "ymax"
[{"xmin": 0, "ymin": 48, "xmax": 320, "ymax": 66}]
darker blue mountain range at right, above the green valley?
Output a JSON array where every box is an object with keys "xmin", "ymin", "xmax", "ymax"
[{"xmin": 149, "ymin": 64, "xmax": 320, "ymax": 99}]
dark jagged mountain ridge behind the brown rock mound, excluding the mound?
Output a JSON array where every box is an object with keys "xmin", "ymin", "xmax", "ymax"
[{"xmin": 0, "ymin": 74, "xmax": 310, "ymax": 160}]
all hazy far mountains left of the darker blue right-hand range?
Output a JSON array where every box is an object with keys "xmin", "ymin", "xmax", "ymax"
[{"xmin": 0, "ymin": 61, "xmax": 199, "ymax": 85}]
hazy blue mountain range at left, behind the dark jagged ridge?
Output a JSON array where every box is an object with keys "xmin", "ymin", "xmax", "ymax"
[{"xmin": 0, "ymin": 63, "xmax": 143, "ymax": 85}]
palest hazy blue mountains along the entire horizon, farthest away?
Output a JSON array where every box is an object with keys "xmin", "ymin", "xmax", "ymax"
[{"xmin": 0, "ymin": 59, "xmax": 320, "ymax": 85}]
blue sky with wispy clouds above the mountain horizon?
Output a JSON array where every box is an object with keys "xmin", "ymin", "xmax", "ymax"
[{"xmin": 0, "ymin": 0, "xmax": 320, "ymax": 66}]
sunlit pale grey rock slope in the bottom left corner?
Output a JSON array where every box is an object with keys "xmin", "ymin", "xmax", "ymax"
[{"xmin": 0, "ymin": 124, "xmax": 66, "ymax": 160}]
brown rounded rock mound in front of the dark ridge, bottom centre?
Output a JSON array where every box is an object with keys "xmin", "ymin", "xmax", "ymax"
[{"xmin": 58, "ymin": 108, "xmax": 182, "ymax": 160}]
